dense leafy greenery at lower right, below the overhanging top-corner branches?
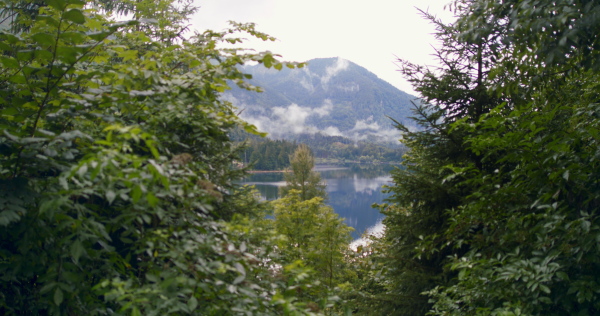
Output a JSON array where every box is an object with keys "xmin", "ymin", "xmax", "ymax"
[{"xmin": 432, "ymin": 81, "xmax": 600, "ymax": 315}]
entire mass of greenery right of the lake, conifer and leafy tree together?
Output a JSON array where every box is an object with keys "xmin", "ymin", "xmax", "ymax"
[{"xmin": 370, "ymin": 0, "xmax": 600, "ymax": 315}]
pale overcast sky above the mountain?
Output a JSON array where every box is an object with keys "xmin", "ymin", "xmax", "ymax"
[{"xmin": 192, "ymin": 0, "xmax": 452, "ymax": 93}]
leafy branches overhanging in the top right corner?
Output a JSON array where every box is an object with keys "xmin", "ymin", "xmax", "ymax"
[{"xmin": 454, "ymin": 0, "xmax": 600, "ymax": 91}]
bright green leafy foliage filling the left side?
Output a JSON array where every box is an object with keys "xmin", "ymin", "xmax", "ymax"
[{"xmin": 0, "ymin": 0, "xmax": 318, "ymax": 315}]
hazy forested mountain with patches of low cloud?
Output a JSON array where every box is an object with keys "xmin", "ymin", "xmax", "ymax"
[{"xmin": 224, "ymin": 58, "xmax": 417, "ymax": 142}]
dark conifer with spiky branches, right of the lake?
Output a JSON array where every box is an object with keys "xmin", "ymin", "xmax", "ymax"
[{"xmin": 356, "ymin": 7, "xmax": 500, "ymax": 315}]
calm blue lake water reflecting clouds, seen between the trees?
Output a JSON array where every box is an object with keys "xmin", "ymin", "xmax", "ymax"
[{"xmin": 244, "ymin": 164, "xmax": 394, "ymax": 239}]
